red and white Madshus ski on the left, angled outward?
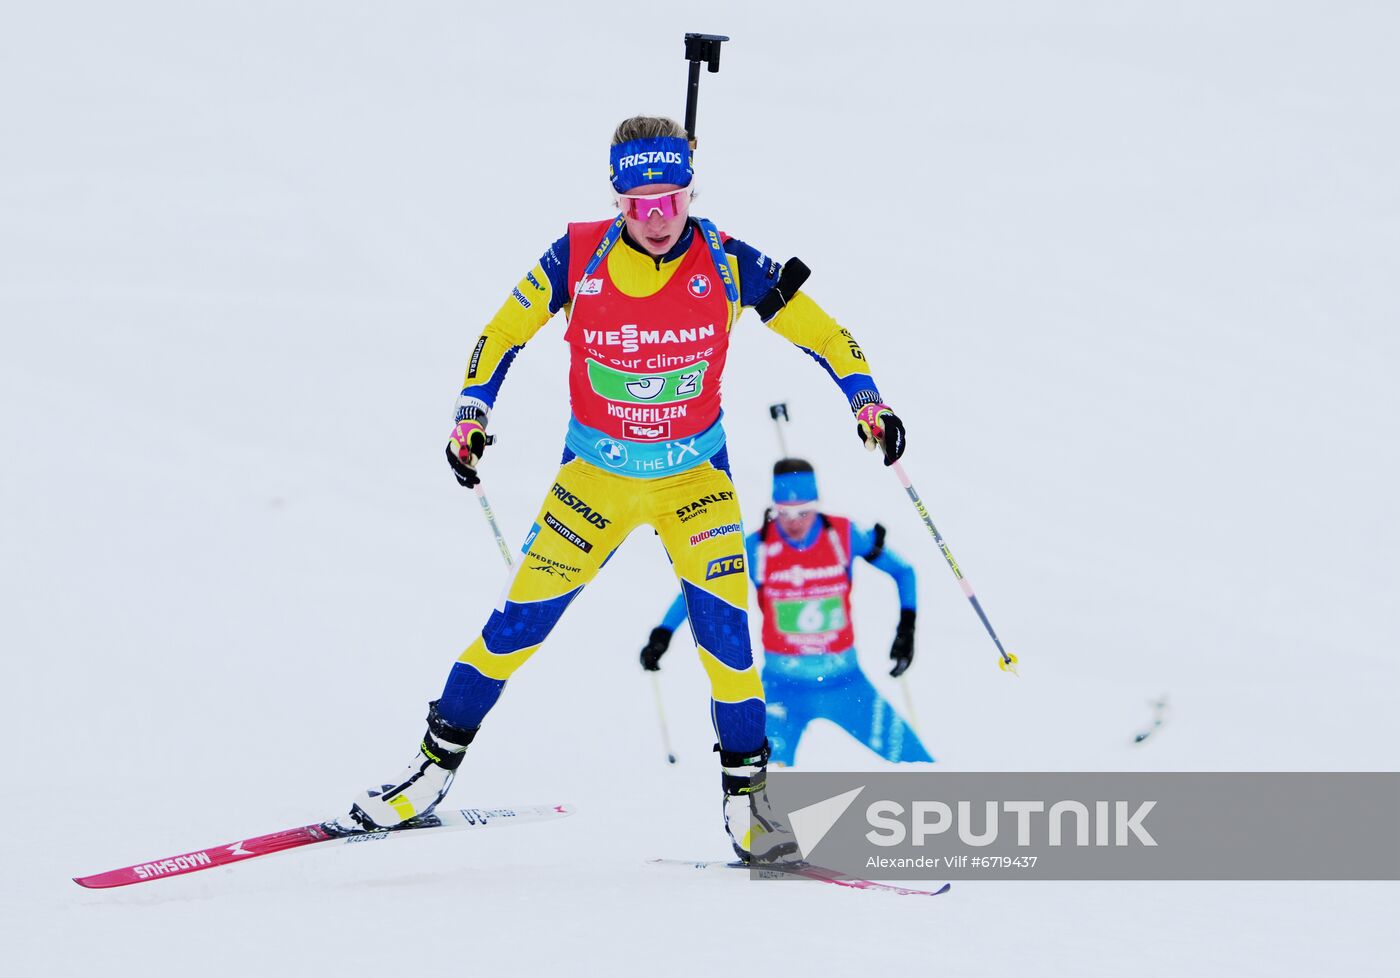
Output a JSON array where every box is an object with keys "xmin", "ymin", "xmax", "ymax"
[{"xmin": 73, "ymin": 805, "xmax": 574, "ymax": 890}]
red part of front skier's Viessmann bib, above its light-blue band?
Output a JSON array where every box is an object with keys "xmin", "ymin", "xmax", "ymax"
[{"xmin": 564, "ymin": 222, "xmax": 731, "ymax": 444}]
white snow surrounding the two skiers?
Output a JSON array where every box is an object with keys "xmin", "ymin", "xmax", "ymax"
[{"xmin": 0, "ymin": 0, "xmax": 1400, "ymax": 977}]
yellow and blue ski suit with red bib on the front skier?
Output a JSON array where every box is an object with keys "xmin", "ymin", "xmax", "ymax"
[{"xmin": 438, "ymin": 217, "xmax": 881, "ymax": 751}]
